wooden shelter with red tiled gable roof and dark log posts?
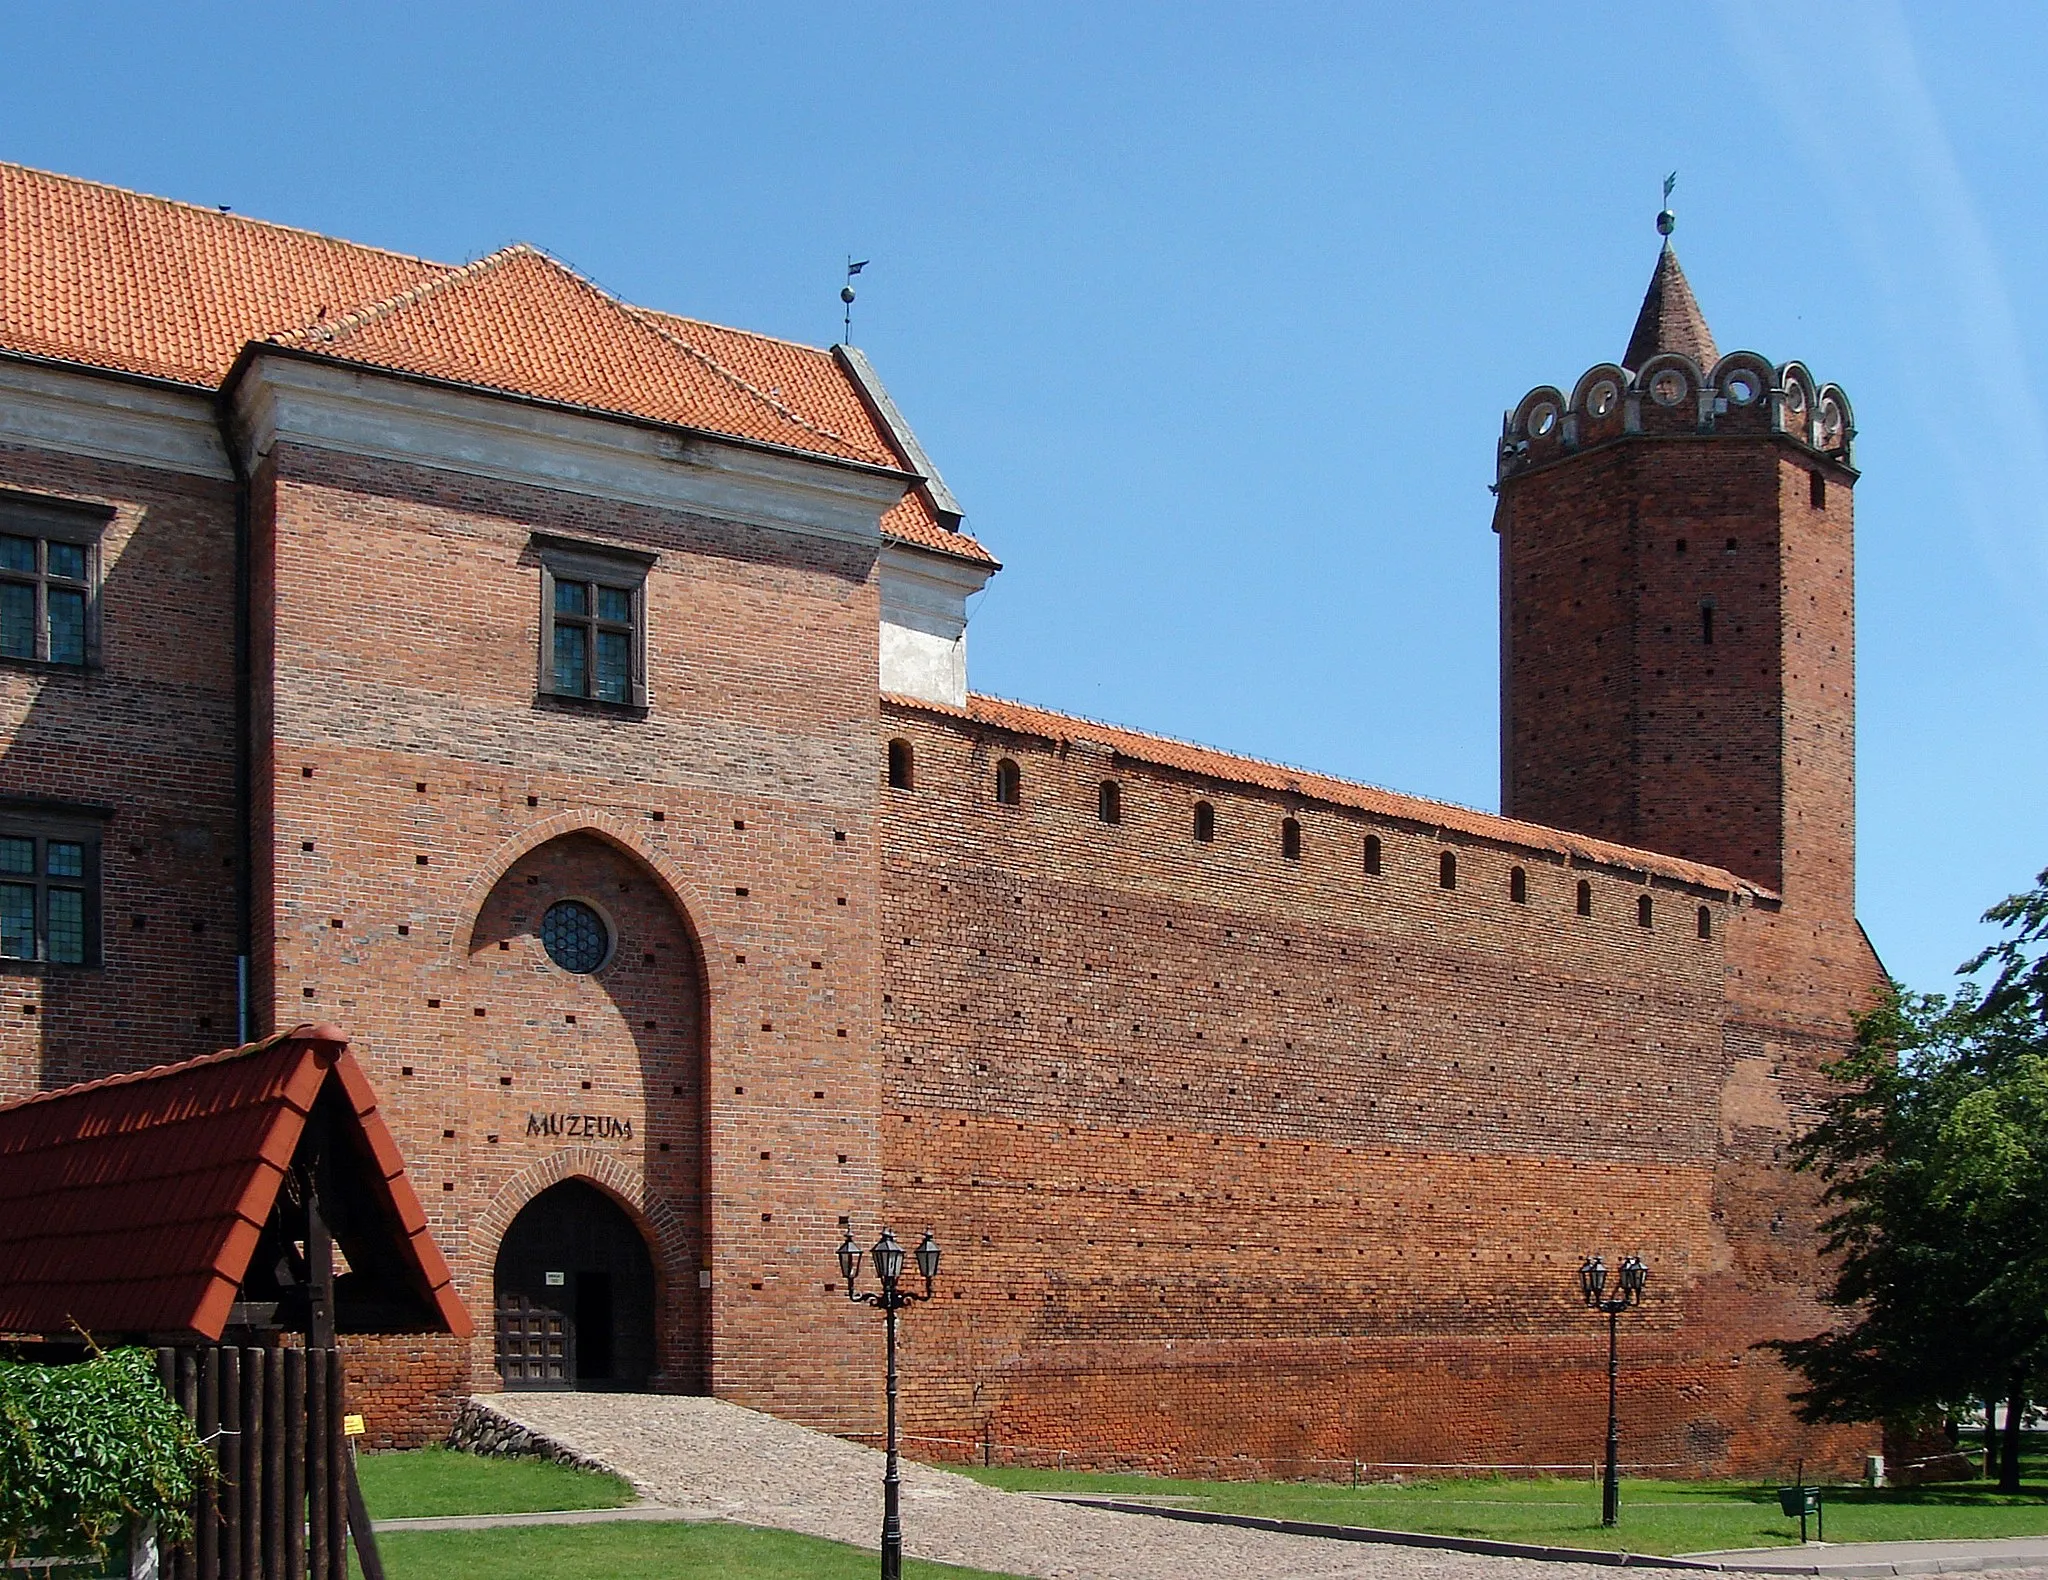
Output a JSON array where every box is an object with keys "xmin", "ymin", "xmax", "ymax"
[{"xmin": 0, "ymin": 1025, "xmax": 471, "ymax": 1580}]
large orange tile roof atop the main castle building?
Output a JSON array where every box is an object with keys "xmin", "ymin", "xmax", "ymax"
[{"xmin": 0, "ymin": 164, "xmax": 989, "ymax": 562}]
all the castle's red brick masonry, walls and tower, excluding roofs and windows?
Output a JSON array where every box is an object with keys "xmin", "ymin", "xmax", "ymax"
[{"xmin": 0, "ymin": 336, "xmax": 1876, "ymax": 1471}]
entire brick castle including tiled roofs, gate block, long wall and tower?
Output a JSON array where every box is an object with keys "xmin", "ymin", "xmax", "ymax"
[{"xmin": 0, "ymin": 166, "xmax": 1880, "ymax": 1471}]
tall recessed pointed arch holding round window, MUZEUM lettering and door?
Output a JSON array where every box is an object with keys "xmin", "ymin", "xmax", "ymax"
[{"xmin": 464, "ymin": 826, "xmax": 709, "ymax": 1391}]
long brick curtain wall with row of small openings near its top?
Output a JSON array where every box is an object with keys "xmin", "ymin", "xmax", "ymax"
[{"xmin": 883, "ymin": 703, "xmax": 1866, "ymax": 1471}]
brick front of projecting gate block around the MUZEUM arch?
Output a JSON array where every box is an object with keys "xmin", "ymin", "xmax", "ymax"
[{"xmin": 258, "ymin": 449, "xmax": 879, "ymax": 1430}]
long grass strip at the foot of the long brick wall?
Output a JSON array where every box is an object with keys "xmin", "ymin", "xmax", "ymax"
[{"xmin": 967, "ymin": 1467, "xmax": 2048, "ymax": 1553}]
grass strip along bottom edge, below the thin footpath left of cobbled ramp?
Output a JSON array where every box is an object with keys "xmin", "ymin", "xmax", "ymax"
[{"xmin": 377, "ymin": 1523, "xmax": 1014, "ymax": 1580}]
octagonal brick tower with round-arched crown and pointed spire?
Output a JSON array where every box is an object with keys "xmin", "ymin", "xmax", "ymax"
[{"xmin": 1495, "ymin": 209, "xmax": 1858, "ymax": 924}]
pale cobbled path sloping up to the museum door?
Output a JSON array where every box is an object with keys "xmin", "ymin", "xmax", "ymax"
[{"xmin": 479, "ymin": 1394, "xmax": 1728, "ymax": 1580}]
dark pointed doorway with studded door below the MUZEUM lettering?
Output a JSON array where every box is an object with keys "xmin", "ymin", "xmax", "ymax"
[{"xmin": 494, "ymin": 1180, "xmax": 655, "ymax": 1389}]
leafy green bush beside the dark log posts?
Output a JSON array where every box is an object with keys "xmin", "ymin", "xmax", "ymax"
[{"xmin": 0, "ymin": 1348, "xmax": 213, "ymax": 1557}]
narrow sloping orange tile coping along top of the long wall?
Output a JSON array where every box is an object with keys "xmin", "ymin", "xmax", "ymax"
[{"xmin": 883, "ymin": 693, "xmax": 1776, "ymax": 898}]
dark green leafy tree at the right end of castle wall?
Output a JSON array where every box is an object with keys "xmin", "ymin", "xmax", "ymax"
[{"xmin": 1772, "ymin": 871, "xmax": 2048, "ymax": 1492}]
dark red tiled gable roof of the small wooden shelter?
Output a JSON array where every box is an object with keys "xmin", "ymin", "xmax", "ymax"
[{"xmin": 0, "ymin": 1025, "xmax": 471, "ymax": 1340}]
